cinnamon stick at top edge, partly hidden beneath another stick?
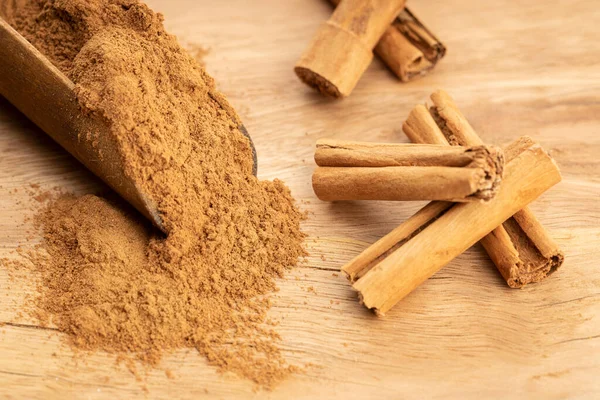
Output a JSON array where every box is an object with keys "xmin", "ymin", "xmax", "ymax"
[{"xmin": 329, "ymin": 0, "xmax": 446, "ymax": 82}]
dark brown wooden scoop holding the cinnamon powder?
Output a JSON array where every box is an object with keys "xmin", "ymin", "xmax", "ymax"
[{"xmin": 0, "ymin": 18, "xmax": 257, "ymax": 233}]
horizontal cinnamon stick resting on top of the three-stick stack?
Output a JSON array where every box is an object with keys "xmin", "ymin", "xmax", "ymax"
[{"xmin": 312, "ymin": 139, "xmax": 504, "ymax": 202}]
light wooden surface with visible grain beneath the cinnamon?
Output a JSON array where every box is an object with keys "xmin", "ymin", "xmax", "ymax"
[{"xmin": 0, "ymin": 0, "xmax": 600, "ymax": 399}]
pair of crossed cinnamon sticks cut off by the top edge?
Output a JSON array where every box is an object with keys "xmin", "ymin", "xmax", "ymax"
[{"xmin": 294, "ymin": 0, "xmax": 446, "ymax": 98}]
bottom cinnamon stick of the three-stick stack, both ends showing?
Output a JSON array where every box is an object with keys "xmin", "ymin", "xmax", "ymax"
[{"xmin": 403, "ymin": 91, "xmax": 564, "ymax": 288}]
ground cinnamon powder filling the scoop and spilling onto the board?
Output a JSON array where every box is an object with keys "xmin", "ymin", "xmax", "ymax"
[{"xmin": 0, "ymin": 0, "xmax": 304, "ymax": 387}]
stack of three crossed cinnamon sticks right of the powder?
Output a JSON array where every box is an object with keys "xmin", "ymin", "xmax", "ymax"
[{"xmin": 313, "ymin": 91, "xmax": 564, "ymax": 315}]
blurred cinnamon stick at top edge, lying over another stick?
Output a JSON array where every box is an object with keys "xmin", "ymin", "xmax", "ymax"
[{"xmin": 294, "ymin": 0, "xmax": 405, "ymax": 98}]
